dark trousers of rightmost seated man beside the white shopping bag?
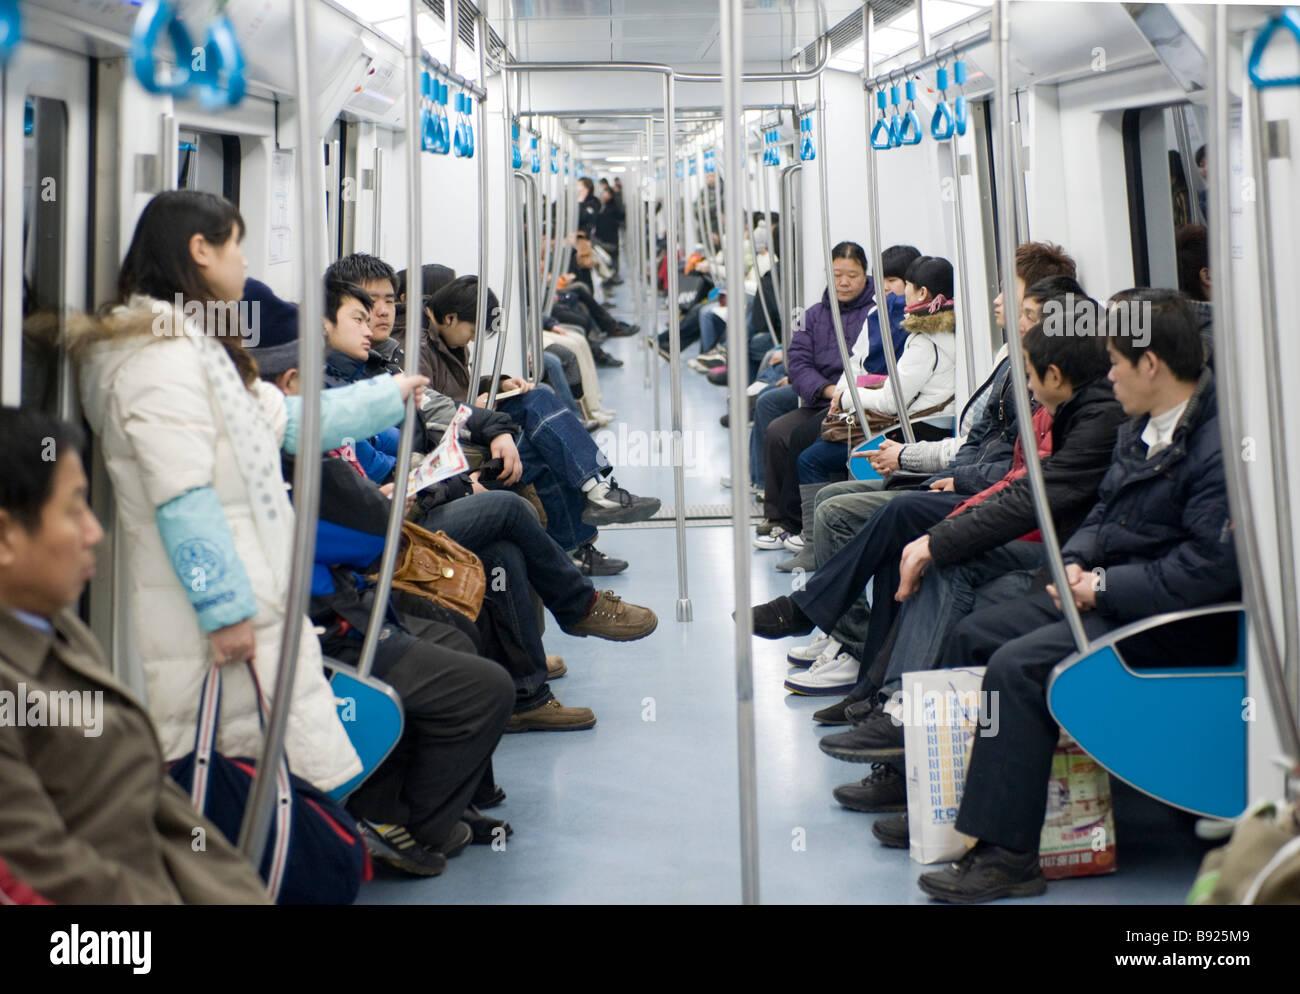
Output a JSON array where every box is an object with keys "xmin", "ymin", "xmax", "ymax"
[{"xmin": 941, "ymin": 591, "xmax": 1236, "ymax": 852}]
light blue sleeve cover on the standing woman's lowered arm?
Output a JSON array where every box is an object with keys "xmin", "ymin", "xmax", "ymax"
[{"xmin": 153, "ymin": 487, "xmax": 257, "ymax": 634}]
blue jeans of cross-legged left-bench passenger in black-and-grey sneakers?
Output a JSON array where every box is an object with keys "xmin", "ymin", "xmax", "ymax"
[{"xmin": 498, "ymin": 390, "xmax": 610, "ymax": 551}]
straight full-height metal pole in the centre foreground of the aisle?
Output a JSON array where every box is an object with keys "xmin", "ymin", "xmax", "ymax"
[{"xmin": 720, "ymin": 0, "xmax": 759, "ymax": 904}]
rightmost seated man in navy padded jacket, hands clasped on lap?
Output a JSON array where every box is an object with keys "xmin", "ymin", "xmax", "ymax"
[{"xmin": 919, "ymin": 290, "xmax": 1240, "ymax": 903}]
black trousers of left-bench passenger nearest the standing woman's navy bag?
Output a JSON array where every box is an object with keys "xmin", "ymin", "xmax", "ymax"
[{"xmin": 340, "ymin": 616, "xmax": 515, "ymax": 846}]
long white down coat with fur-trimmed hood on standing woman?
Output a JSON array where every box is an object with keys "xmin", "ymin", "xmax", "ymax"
[{"xmin": 72, "ymin": 298, "xmax": 361, "ymax": 790}]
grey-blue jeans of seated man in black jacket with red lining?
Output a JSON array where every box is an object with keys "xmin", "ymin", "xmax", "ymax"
[{"xmin": 885, "ymin": 542, "xmax": 1045, "ymax": 689}]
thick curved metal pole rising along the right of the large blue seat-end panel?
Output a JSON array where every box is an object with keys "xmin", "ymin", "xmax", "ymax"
[{"xmin": 1211, "ymin": 11, "xmax": 1300, "ymax": 758}]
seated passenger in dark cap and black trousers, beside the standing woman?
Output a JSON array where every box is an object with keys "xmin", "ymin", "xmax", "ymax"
[{"xmin": 250, "ymin": 283, "xmax": 515, "ymax": 876}]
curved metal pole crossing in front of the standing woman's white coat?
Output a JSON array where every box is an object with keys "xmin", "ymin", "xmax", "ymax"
[{"xmin": 238, "ymin": 0, "xmax": 330, "ymax": 867}]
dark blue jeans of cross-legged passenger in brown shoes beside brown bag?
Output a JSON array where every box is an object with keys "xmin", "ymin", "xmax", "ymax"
[{"xmin": 420, "ymin": 490, "xmax": 595, "ymax": 711}]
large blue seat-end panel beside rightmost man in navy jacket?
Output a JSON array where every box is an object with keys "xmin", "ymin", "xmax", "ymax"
[{"xmin": 1047, "ymin": 604, "xmax": 1247, "ymax": 819}]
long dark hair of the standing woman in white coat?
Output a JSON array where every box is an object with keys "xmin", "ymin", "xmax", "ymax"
[{"xmin": 117, "ymin": 190, "xmax": 257, "ymax": 385}]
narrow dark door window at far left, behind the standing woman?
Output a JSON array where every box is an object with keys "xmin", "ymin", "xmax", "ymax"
[{"xmin": 21, "ymin": 96, "xmax": 68, "ymax": 413}]
